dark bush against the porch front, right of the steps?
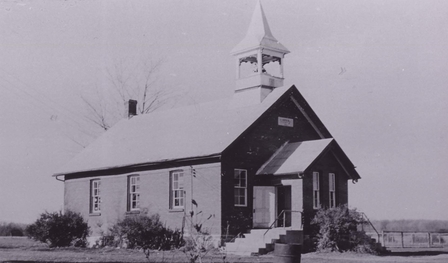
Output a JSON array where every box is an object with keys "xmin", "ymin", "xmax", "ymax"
[{"xmin": 311, "ymin": 205, "xmax": 375, "ymax": 253}]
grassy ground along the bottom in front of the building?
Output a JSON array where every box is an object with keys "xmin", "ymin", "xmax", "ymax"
[{"xmin": 0, "ymin": 237, "xmax": 448, "ymax": 263}]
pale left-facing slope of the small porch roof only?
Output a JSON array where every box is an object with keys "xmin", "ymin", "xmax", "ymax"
[{"xmin": 257, "ymin": 138, "xmax": 333, "ymax": 175}]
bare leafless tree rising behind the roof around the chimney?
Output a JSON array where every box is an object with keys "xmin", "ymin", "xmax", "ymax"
[{"xmin": 81, "ymin": 59, "xmax": 170, "ymax": 131}]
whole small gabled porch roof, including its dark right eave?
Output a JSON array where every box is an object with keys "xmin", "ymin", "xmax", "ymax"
[{"xmin": 257, "ymin": 138, "xmax": 361, "ymax": 180}]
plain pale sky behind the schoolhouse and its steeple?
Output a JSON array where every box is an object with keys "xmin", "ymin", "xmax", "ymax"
[{"xmin": 0, "ymin": 0, "xmax": 448, "ymax": 223}]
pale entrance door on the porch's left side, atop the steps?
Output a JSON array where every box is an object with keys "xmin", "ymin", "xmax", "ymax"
[{"xmin": 253, "ymin": 186, "xmax": 276, "ymax": 228}]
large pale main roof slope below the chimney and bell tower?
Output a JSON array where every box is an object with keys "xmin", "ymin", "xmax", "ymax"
[{"xmin": 55, "ymin": 86, "xmax": 298, "ymax": 175}]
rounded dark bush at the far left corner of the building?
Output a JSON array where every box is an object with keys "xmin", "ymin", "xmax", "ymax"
[{"xmin": 26, "ymin": 211, "xmax": 89, "ymax": 247}]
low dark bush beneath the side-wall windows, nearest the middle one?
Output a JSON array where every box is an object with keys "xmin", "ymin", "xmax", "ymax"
[{"xmin": 107, "ymin": 214, "xmax": 184, "ymax": 250}]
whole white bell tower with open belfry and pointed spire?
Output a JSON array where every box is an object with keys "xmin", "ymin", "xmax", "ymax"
[{"xmin": 231, "ymin": 1, "xmax": 289, "ymax": 104}]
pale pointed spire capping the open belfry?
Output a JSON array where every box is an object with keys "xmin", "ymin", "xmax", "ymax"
[{"xmin": 231, "ymin": 0, "xmax": 289, "ymax": 54}]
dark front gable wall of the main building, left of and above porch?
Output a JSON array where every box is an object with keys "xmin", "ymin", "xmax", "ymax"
[{"xmin": 221, "ymin": 98, "xmax": 326, "ymax": 234}]
